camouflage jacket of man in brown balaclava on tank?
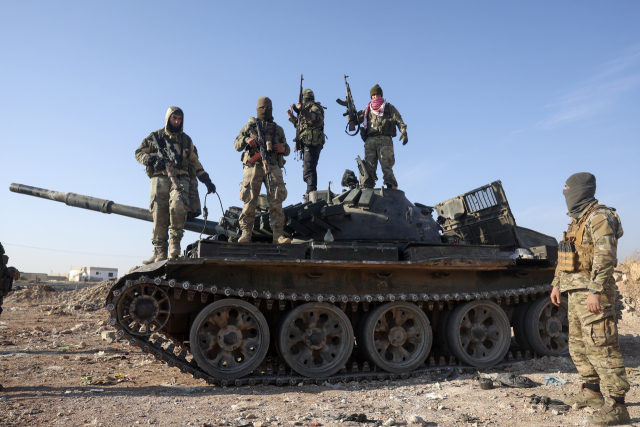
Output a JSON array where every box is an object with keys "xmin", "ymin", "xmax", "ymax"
[{"xmin": 233, "ymin": 117, "xmax": 291, "ymax": 167}]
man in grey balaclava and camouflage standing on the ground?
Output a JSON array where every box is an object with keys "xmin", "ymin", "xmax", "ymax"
[{"xmin": 551, "ymin": 172, "xmax": 630, "ymax": 425}]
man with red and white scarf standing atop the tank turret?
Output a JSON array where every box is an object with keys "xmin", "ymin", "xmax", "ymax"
[{"xmin": 358, "ymin": 85, "xmax": 409, "ymax": 189}]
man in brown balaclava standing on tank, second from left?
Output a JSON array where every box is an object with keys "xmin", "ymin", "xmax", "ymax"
[{"xmin": 233, "ymin": 96, "xmax": 291, "ymax": 243}]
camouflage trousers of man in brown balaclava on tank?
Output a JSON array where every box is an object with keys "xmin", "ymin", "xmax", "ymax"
[{"xmin": 239, "ymin": 164, "xmax": 287, "ymax": 232}]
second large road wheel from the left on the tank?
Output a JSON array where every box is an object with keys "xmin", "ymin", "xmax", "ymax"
[{"xmin": 276, "ymin": 302, "xmax": 353, "ymax": 378}]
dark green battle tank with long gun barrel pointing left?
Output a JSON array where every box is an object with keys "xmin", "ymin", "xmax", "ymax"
[{"xmin": 10, "ymin": 177, "xmax": 568, "ymax": 386}]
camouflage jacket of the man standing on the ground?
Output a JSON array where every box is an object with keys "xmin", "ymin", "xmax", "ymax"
[{"xmin": 552, "ymin": 201, "xmax": 624, "ymax": 292}]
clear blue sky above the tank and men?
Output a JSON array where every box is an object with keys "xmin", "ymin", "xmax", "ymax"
[{"xmin": 0, "ymin": 1, "xmax": 640, "ymax": 274}]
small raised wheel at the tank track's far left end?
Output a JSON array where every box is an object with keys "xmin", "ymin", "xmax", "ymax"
[{"xmin": 116, "ymin": 283, "xmax": 171, "ymax": 336}]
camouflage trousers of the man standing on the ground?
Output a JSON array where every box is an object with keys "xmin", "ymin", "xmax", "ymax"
[{"xmin": 568, "ymin": 290, "xmax": 629, "ymax": 396}]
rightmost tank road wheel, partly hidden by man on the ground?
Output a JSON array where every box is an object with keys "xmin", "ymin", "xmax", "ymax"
[{"xmin": 524, "ymin": 295, "xmax": 569, "ymax": 356}]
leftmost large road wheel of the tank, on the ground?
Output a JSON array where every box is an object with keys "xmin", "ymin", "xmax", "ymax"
[{"xmin": 189, "ymin": 299, "xmax": 269, "ymax": 380}]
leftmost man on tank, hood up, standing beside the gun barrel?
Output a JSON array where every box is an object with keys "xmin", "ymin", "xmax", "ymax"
[{"xmin": 136, "ymin": 107, "xmax": 216, "ymax": 264}]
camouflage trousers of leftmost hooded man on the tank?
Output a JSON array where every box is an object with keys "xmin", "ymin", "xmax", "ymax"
[{"xmin": 149, "ymin": 175, "xmax": 189, "ymax": 248}]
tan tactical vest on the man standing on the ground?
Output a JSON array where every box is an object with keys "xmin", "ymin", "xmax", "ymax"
[{"xmin": 558, "ymin": 204, "xmax": 621, "ymax": 273}]
